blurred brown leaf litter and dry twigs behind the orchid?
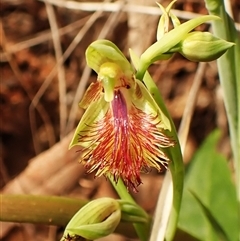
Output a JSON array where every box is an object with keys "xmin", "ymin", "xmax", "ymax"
[{"xmin": 0, "ymin": 0, "xmax": 240, "ymax": 241}]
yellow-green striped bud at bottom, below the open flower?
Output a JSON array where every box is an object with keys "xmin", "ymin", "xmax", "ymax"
[{"xmin": 62, "ymin": 198, "xmax": 121, "ymax": 240}]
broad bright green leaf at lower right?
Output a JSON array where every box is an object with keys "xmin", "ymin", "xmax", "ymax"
[{"xmin": 178, "ymin": 130, "xmax": 239, "ymax": 241}]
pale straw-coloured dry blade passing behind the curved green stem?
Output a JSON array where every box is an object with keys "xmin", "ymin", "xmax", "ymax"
[{"xmin": 150, "ymin": 63, "xmax": 206, "ymax": 241}]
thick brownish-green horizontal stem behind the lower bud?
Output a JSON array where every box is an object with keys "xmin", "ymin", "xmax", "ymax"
[{"xmin": 0, "ymin": 194, "xmax": 137, "ymax": 238}]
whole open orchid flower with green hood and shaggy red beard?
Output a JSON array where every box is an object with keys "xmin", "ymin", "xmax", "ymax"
[{"xmin": 70, "ymin": 40, "xmax": 175, "ymax": 191}]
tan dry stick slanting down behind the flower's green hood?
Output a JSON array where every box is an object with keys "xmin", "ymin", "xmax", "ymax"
[{"xmin": 66, "ymin": 0, "xmax": 125, "ymax": 132}]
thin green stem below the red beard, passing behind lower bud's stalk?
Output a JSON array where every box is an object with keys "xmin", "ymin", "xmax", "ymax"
[{"xmin": 109, "ymin": 177, "xmax": 151, "ymax": 241}]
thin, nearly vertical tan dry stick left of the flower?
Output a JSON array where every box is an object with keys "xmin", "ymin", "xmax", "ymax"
[{"xmin": 45, "ymin": 3, "xmax": 67, "ymax": 140}]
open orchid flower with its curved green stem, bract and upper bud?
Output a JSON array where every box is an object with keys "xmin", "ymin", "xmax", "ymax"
[{"xmin": 68, "ymin": 2, "xmax": 232, "ymax": 241}]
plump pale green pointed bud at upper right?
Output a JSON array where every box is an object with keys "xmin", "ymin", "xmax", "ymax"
[{"xmin": 177, "ymin": 31, "xmax": 234, "ymax": 62}]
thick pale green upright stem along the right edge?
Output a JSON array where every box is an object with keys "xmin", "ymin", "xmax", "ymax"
[{"xmin": 205, "ymin": 0, "xmax": 240, "ymax": 202}]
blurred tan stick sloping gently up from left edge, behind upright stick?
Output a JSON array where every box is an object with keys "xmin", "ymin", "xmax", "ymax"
[{"xmin": 0, "ymin": 16, "xmax": 89, "ymax": 62}]
